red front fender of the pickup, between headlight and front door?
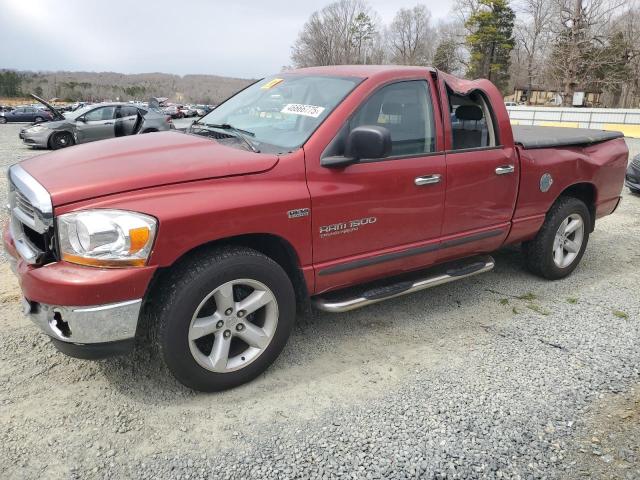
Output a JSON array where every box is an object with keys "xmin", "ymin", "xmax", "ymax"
[{"xmin": 55, "ymin": 149, "xmax": 311, "ymax": 278}]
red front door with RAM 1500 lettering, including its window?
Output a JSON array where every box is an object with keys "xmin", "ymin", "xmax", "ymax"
[{"xmin": 305, "ymin": 78, "xmax": 445, "ymax": 293}]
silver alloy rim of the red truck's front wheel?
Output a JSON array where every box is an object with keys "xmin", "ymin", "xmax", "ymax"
[{"xmin": 189, "ymin": 279, "xmax": 278, "ymax": 373}]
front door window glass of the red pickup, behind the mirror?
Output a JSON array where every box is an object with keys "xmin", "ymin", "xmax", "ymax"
[{"xmin": 349, "ymin": 80, "xmax": 435, "ymax": 156}]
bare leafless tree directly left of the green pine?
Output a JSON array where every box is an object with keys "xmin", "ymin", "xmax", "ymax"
[{"xmin": 389, "ymin": 5, "xmax": 434, "ymax": 65}]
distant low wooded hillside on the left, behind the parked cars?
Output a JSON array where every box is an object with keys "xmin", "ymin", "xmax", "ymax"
[{"xmin": 0, "ymin": 70, "xmax": 251, "ymax": 104}]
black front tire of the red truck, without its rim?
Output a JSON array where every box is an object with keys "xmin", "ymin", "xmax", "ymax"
[{"xmin": 150, "ymin": 247, "xmax": 296, "ymax": 392}]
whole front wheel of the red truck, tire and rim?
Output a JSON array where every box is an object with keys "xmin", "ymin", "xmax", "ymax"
[{"xmin": 152, "ymin": 248, "xmax": 295, "ymax": 392}]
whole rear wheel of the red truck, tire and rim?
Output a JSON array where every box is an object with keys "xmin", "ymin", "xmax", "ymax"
[{"xmin": 522, "ymin": 197, "xmax": 591, "ymax": 280}]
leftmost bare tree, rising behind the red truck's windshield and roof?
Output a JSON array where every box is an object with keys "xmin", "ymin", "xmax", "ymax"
[{"xmin": 291, "ymin": 0, "xmax": 378, "ymax": 67}]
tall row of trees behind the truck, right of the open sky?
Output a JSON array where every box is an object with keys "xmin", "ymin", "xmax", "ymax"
[{"xmin": 291, "ymin": 0, "xmax": 640, "ymax": 107}]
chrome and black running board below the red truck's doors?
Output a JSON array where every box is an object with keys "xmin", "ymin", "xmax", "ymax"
[{"xmin": 312, "ymin": 256, "xmax": 495, "ymax": 313}]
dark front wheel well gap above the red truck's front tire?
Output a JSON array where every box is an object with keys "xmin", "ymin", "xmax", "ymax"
[{"xmin": 155, "ymin": 233, "xmax": 311, "ymax": 314}]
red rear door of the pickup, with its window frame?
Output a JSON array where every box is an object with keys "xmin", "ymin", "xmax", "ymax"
[{"xmin": 439, "ymin": 90, "xmax": 519, "ymax": 260}]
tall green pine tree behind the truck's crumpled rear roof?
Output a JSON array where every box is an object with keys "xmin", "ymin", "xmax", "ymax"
[{"xmin": 466, "ymin": 0, "xmax": 515, "ymax": 90}]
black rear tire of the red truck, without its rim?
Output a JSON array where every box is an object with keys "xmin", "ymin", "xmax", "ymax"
[{"xmin": 522, "ymin": 197, "xmax": 593, "ymax": 280}]
